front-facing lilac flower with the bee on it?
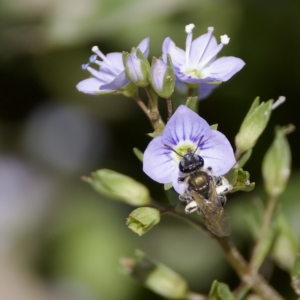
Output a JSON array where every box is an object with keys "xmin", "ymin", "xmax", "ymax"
[{"xmin": 143, "ymin": 105, "xmax": 235, "ymax": 194}]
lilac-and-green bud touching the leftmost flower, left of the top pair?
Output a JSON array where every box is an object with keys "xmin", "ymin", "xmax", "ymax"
[{"xmin": 122, "ymin": 49, "xmax": 150, "ymax": 87}]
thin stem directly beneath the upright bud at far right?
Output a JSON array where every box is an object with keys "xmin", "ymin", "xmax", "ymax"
[{"xmin": 250, "ymin": 196, "xmax": 277, "ymax": 272}]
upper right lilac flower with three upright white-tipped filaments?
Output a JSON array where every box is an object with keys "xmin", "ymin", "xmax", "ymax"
[{"xmin": 162, "ymin": 24, "xmax": 245, "ymax": 92}]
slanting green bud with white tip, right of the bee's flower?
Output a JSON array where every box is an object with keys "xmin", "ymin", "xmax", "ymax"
[{"xmin": 235, "ymin": 97, "xmax": 273, "ymax": 153}]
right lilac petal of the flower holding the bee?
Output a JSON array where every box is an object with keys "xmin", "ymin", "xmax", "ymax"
[{"xmin": 200, "ymin": 130, "xmax": 236, "ymax": 176}]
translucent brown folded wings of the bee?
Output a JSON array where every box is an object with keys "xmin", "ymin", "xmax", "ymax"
[{"xmin": 191, "ymin": 180, "xmax": 231, "ymax": 237}]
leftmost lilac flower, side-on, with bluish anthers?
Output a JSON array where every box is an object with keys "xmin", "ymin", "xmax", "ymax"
[{"xmin": 76, "ymin": 38, "xmax": 149, "ymax": 95}]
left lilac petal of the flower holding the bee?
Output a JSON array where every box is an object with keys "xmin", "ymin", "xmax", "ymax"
[{"xmin": 143, "ymin": 136, "xmax": 179, "ymax": 183}]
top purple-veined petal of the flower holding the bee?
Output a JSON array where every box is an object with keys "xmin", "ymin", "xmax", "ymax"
[{"xmin": 162, "ymin": 105, "xmax": 212, "ymax": 146}]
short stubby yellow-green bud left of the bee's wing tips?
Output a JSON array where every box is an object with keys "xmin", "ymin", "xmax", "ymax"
[{"xmin": 126, "ymin": 207, "xmax": 160, "ymax": 236}]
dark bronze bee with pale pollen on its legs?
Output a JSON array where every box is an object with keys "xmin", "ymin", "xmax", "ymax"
[{"xmin": 165, "ymin": 139, "xmax": 232, "ymax": 237}]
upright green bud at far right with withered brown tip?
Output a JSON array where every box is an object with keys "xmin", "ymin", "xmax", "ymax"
[{"xmin": 262, "ymin": 125, "xmax": 294, "ymax": 197}]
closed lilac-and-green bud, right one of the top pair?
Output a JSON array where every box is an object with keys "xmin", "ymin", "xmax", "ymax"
[{"xmin": 150, "ymin": 54, "xmax": 175, "ymax": 98}]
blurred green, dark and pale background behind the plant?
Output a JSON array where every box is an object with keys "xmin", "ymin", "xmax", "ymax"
[{"xmin": 0, "ymin": 0, "xmax": 300, "ymax": 300}]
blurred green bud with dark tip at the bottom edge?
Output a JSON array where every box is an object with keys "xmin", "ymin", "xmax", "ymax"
[{"xmin": 121, "ymin": 251, "xmax": 188, "ymax": 299}]
